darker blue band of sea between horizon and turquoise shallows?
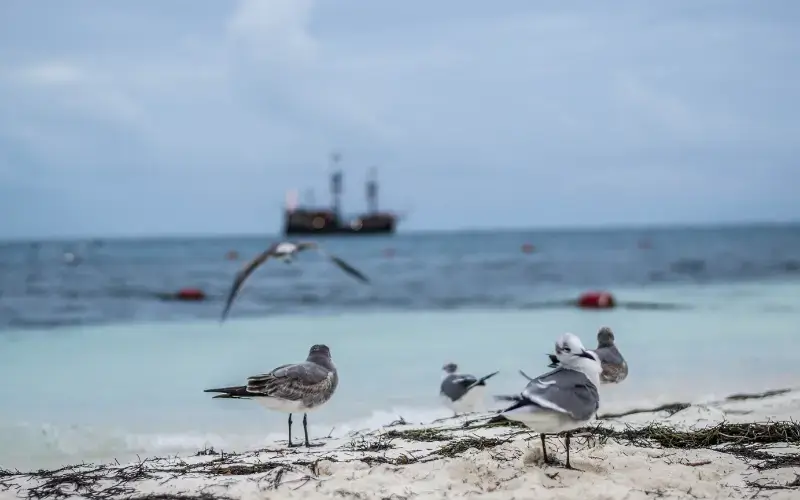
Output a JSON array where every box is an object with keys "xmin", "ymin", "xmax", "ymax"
[{"xmin": 0, "ymin": 225, "xmax": 800, "ymax": 334}]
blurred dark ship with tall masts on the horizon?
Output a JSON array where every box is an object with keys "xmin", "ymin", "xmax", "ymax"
[{"xmin": 283, "ymin": 153, "xmax": 398, "ymax": 235}]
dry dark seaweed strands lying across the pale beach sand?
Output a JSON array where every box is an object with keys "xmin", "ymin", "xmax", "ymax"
[{"xmin": 6, "ymin": 414, "xmax": 800, "ymax": 500}]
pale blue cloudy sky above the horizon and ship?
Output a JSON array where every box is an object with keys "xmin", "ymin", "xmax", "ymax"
[{"xmin": 0, "ymin": 0, "xmax": 800, "ymax": 239}]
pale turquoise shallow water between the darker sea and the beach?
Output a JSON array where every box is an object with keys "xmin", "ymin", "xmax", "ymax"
[{"xmin": 0, "ymin": 282, "xmax": 800, "ymax": 468}]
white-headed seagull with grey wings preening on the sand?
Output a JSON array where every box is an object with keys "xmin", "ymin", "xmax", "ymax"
[{"xmin": 495, "ymin": 333, "xmax": 602, "ymax": 469}]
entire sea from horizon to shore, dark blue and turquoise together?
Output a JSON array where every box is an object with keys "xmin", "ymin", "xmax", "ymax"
[{"xmin": 0, "ymin": 225, "xmax": 800, "ymax": 469}]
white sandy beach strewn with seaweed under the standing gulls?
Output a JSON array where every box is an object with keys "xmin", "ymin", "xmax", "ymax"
[{"xmin": 0, "ymin": 390, "xmax": 800, "ymax": 500}]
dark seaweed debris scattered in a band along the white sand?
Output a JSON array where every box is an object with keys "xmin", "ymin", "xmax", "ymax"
[{"xmin": 0, "ymin": 421, "xmax": 800, "ymax": 500}]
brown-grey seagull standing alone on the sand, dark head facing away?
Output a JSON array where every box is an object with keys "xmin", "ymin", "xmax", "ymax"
[{"xmin": 203, "ymin": 344, "xmax": 339, "ymax": 448}]
